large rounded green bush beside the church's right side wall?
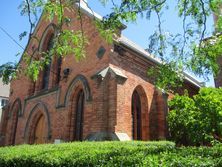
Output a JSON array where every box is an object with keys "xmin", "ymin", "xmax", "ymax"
[{"xmin": 168, "ymin": 88, "xmax": 222, "ymax": 145}]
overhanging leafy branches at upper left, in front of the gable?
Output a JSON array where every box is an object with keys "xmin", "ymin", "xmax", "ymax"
[{"xmin": 0, "ymin": 0, "xmax": 88, "ymax": 82}]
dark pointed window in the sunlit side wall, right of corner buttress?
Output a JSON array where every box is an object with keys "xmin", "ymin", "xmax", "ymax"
[{"xmin": 132, "ymin": 90, "xmax": 142, "ymax": 140}]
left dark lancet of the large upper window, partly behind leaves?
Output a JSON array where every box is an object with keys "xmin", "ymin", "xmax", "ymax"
[{"xmin": 42, "ymin": 34, "xmax": 54, "ymax": 89}]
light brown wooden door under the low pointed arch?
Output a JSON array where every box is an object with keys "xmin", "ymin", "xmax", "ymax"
[{"xmin": 34, "ymin": 116, "xmax": 46, "ymax": 144}]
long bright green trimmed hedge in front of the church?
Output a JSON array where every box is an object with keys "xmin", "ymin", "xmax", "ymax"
[{"xmin": 0, "ymin": 142, "xmax": 175, "ymax": 167}]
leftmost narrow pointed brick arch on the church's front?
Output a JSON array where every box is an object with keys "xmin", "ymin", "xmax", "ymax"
[{"xmin": 9, "ymin": 98, "xmax": 22, "ymax": 145}]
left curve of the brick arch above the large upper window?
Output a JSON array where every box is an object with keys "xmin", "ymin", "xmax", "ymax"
[{"xmin": 38, "ymin": 23, "xmax": 57, "ymax": 52}]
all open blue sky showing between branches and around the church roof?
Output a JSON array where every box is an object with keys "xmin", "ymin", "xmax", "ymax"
[{"xmin": 0, "ymin": 0, "xmax": 214, "ymax": 86}]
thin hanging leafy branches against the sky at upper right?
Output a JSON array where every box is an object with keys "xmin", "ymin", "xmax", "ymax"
[{"xmin": 98, "ymin": 0, "xmax": 222, "ymax": 88}]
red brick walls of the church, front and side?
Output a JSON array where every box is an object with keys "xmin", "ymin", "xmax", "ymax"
[{"xmin": 1, "ymin": 3, "xmax": 198, "ymax": 145}]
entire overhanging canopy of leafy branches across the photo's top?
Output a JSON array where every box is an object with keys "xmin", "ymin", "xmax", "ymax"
[{"xmin": 0, "ymin": 0, "xmax": 222, "ymax": 91}]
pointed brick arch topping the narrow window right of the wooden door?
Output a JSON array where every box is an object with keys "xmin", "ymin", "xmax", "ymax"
[{"xmin": 65, "ymin": 74, "xmax": 92, "ymax": 106}]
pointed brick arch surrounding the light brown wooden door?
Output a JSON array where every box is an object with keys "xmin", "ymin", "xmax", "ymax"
[{"xmin": 24, "ymin": 102, "xmax": 51, "ymax": 144}]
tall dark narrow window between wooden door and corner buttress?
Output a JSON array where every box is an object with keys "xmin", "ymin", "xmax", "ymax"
[{"xmin": 74, "ymin": 90, "xmax": 85, "ymax": 141}]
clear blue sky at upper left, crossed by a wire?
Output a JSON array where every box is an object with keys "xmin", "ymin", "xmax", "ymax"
[{"xmin": 0, "ymin": 0, "xmax": 28, "ymax": 64}]
